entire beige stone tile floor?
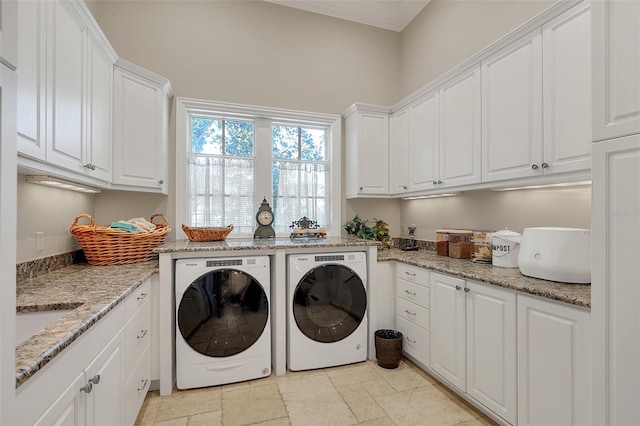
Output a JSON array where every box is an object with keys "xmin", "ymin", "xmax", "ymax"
[{"xmin": 136, "ymin": 361, "xmax": 495, "ymax": 426}]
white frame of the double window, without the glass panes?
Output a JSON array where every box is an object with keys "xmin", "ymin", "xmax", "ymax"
[{"xmin": 175, "ymin": 97, "xmax": 343, "ymax": 239}]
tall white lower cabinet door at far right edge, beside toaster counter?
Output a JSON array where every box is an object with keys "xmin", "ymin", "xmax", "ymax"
[{"xmin": 591, "ymin": 135, "xmax": 640, "ymax": 425}]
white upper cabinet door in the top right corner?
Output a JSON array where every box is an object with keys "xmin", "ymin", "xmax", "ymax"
[{"xmin": 592, "ymin": 0, "xmax": 640, "ymax": 141}]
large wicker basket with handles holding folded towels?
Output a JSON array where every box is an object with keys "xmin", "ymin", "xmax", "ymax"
[{"xmin": 69, "ymin": 213, "xmax": 171, "ymax": 266}]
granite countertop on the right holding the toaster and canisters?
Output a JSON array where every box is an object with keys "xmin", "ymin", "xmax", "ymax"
[{"xmin": 378, "ymin": 248, "xmax": 591, "ymax": 309}]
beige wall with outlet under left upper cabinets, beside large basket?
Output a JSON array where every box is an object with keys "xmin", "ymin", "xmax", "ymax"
[{"xmin": 16, "ymin": 175, "xmax": 96, "ymax": 263}]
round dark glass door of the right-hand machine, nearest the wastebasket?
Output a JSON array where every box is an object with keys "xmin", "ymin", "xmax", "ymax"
[{"xmin": 293, "ymin": 264, "xmax": 367, "ymax": 343}]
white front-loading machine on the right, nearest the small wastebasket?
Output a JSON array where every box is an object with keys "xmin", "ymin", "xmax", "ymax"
[{"xmin": 287, "ymin": 252, "xmax": 367, "ymax": 371}]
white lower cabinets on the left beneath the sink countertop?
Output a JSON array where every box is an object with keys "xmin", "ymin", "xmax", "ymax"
[{"xmin": 13, "ymin": 278, "xmax": 154, "ymax": 425}]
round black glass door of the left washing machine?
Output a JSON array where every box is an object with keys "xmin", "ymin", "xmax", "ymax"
[{"xmin": 178, "ymin": 269, "xmax": 269, "ymax": 357}]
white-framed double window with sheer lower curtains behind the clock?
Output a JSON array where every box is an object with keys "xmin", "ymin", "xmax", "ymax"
[{"xmin": 176, "ymin": 98, "xmax": 341, "ymax": 238}]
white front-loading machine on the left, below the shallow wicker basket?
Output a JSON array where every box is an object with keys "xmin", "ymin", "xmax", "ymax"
[{"xmin": 175, "ymin": 256, "xmax": 271, "ymax": 389}]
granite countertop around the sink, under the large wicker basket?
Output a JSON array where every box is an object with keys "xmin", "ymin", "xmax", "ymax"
[{"xmin": 16, "ymin": 261, "xmax": 158, "ymax": 388}]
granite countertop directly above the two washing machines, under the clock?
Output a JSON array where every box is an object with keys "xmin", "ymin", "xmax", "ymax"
[{"xmin": 154, "ymin": 236, "xmax": 378, "ymax": 253}]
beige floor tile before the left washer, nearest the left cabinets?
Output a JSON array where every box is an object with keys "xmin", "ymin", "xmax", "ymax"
[{"xmin": 156, "ymin": 387, "xmax": 222, "ymax": 422}]
